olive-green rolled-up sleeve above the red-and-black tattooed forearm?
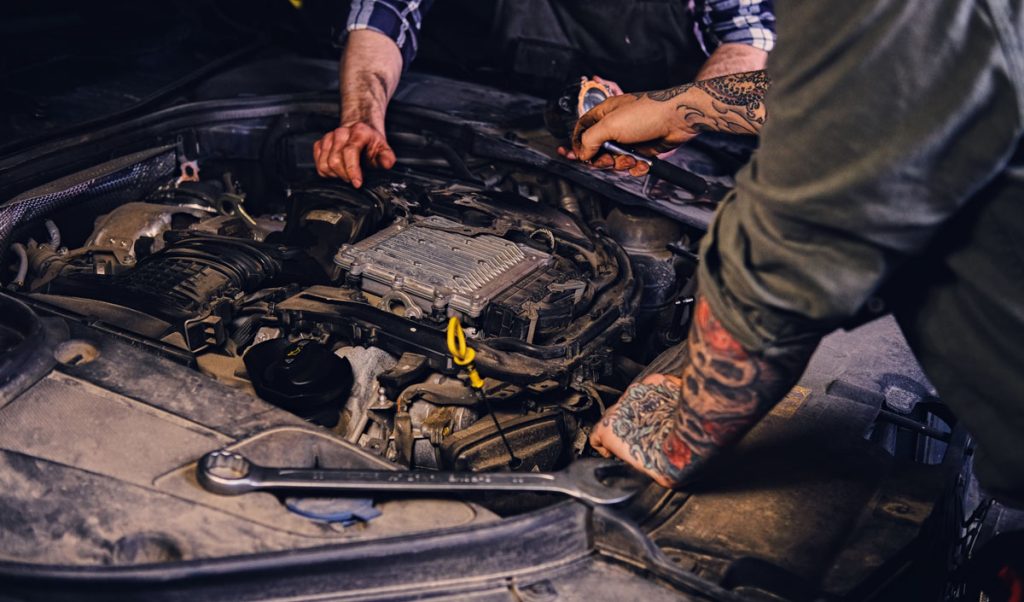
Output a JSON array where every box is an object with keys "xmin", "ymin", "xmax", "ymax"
[{"xmin": 699, "ymin": 0, "xmax": 1021, "ymax": 349}]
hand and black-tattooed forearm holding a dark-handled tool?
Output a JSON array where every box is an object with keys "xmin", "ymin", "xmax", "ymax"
[{"xmin": 572, "ymin": 71, "xmax": 770, "ymax": 173}]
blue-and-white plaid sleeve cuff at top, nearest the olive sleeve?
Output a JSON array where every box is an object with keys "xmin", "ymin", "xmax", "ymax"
[{"xmin": 695, "ymin": 0, "xmax": 775, "ymax": 52}]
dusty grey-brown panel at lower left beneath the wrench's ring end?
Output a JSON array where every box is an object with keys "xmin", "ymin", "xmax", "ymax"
[{"xmin": 0, "ymin": 321, "xmax": 496, "ymax": 565}]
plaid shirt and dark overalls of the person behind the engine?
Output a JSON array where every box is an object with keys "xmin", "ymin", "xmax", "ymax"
[{"xmin": 347, "ymin": 0, "xmax": 775, "ymax": 94}]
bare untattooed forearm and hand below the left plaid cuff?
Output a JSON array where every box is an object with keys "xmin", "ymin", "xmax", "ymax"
[{"xmin": 313, "ymin": 30, "xmax": 401, "ymax": 188}]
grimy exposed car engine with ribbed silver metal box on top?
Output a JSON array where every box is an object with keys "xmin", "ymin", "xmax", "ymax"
[{"xmin": 12, "ymin": 163, "xmax": 655, "ymax": 470}]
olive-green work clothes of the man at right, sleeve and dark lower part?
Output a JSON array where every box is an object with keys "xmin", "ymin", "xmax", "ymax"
[{"xmin": 699, "ymin": 0, "xmax": 1024, "ymax": 502}]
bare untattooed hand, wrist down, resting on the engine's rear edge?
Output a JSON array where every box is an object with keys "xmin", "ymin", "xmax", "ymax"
[{"xmin": 313, "ymin": 123, "xmax": 395, "ymax": 188}]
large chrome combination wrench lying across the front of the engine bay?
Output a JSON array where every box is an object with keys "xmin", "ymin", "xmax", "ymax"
[{"xmin": 197, "ymin": 450, "xmax": 637, "ymax": 506}]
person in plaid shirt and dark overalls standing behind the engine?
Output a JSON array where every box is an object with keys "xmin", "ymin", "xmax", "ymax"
[{"xmin": 313, "ymin": 0, "xmax": 775, "ymax": 187}]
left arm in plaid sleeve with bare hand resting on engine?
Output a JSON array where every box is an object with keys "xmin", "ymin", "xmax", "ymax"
[{"xmin": 313, "ymin": 0, "xmax": 431, "ymax": 188}]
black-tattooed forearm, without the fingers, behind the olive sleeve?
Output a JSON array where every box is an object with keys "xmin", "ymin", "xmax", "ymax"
[{"xmin": 633, "ymin": 71, "xmax": 771, "ymax": 134}]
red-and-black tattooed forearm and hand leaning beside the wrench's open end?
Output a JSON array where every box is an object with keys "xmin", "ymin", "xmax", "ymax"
[{"xmin": 603, "ymin": 298, "xmax": 815, "ymax": 484}]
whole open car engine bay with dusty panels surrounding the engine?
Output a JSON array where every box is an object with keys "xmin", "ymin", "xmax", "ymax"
[{"xmin": 0, "ymin": 76, "xmax": 964, "ymax": 599}]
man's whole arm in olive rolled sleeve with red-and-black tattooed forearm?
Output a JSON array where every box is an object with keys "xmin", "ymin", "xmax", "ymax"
[{"xmin": 585, "ymin": 0, "xmax": 1024, "ymax": 485}]
